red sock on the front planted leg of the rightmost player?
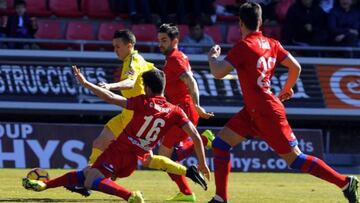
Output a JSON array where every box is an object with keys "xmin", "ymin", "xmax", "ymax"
[{"xmin": 213, "ymin": 147, "xmax": 231, "ymax": 201}]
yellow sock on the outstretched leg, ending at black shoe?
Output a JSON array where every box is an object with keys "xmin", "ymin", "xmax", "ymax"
[{"xmin": 149, "ymin": 155, "xmax": 186, "ymax": 175}]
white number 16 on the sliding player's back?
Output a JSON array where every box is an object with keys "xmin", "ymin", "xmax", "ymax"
[{"xmin": 136, "ymin": 116, "xmax": 165, "ymax": 141}]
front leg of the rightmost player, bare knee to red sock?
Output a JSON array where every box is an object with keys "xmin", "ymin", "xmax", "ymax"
[{"xmin": 210, "ymin": 127, "xmax": 245, "ymax": 203}]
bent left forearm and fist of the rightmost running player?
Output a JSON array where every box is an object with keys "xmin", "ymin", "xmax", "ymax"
[{"xmin": 208, "ymin": 45, "xmax": 233, "ymax": 79}]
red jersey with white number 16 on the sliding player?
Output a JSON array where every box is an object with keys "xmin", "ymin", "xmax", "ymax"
[{"xmin": 115, "ymin": 95, "xmax": 189, "ymax": 159}]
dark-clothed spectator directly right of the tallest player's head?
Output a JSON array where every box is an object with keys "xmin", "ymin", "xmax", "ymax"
[{"xmin": 282, "ymin": 0, "xmax": 328, "ymax": 46}]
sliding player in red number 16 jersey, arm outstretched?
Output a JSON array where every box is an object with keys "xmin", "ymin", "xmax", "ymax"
[{"xmin": 23, "ymin": 66, "xmax": 210, "ymax": 203}]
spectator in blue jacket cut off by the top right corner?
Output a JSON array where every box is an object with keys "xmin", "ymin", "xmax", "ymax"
[{"xmin": 329, "ymin": 0, "xmax": 360, "ymax": 46}]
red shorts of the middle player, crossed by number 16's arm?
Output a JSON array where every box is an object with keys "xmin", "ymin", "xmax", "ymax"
[{"xmin": 162, "ymin": 101, "xmax": 199, "ymax": 148}]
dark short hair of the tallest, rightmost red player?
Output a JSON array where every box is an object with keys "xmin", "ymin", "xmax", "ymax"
[{"xmin": 239, "ymin": 2, "xmax": 262, "ymax": 30}]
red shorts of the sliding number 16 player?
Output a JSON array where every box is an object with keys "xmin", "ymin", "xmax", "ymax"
[{"xmin": 92, "ymin": 143, "xmax": 137, "ymax": 178}]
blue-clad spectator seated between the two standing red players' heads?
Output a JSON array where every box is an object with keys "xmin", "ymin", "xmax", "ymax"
[{"xmin": 182, "ymin": 21, "xmax": 214, "ymax": 54}]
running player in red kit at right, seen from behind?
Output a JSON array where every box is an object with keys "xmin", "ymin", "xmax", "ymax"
[{"xmin": 208, "ymin": 2, "xmax": 359, "ymax": 203}]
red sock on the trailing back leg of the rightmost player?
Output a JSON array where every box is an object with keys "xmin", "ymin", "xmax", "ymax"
[{"xmin": 301, "ymin": 155, "xmax": 348, "ymax": 188}]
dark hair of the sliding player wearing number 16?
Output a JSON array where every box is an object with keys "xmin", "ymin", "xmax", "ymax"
[{"xmin": 142, "ymin": 68, "xmax": 165, "ymax": 94}]
